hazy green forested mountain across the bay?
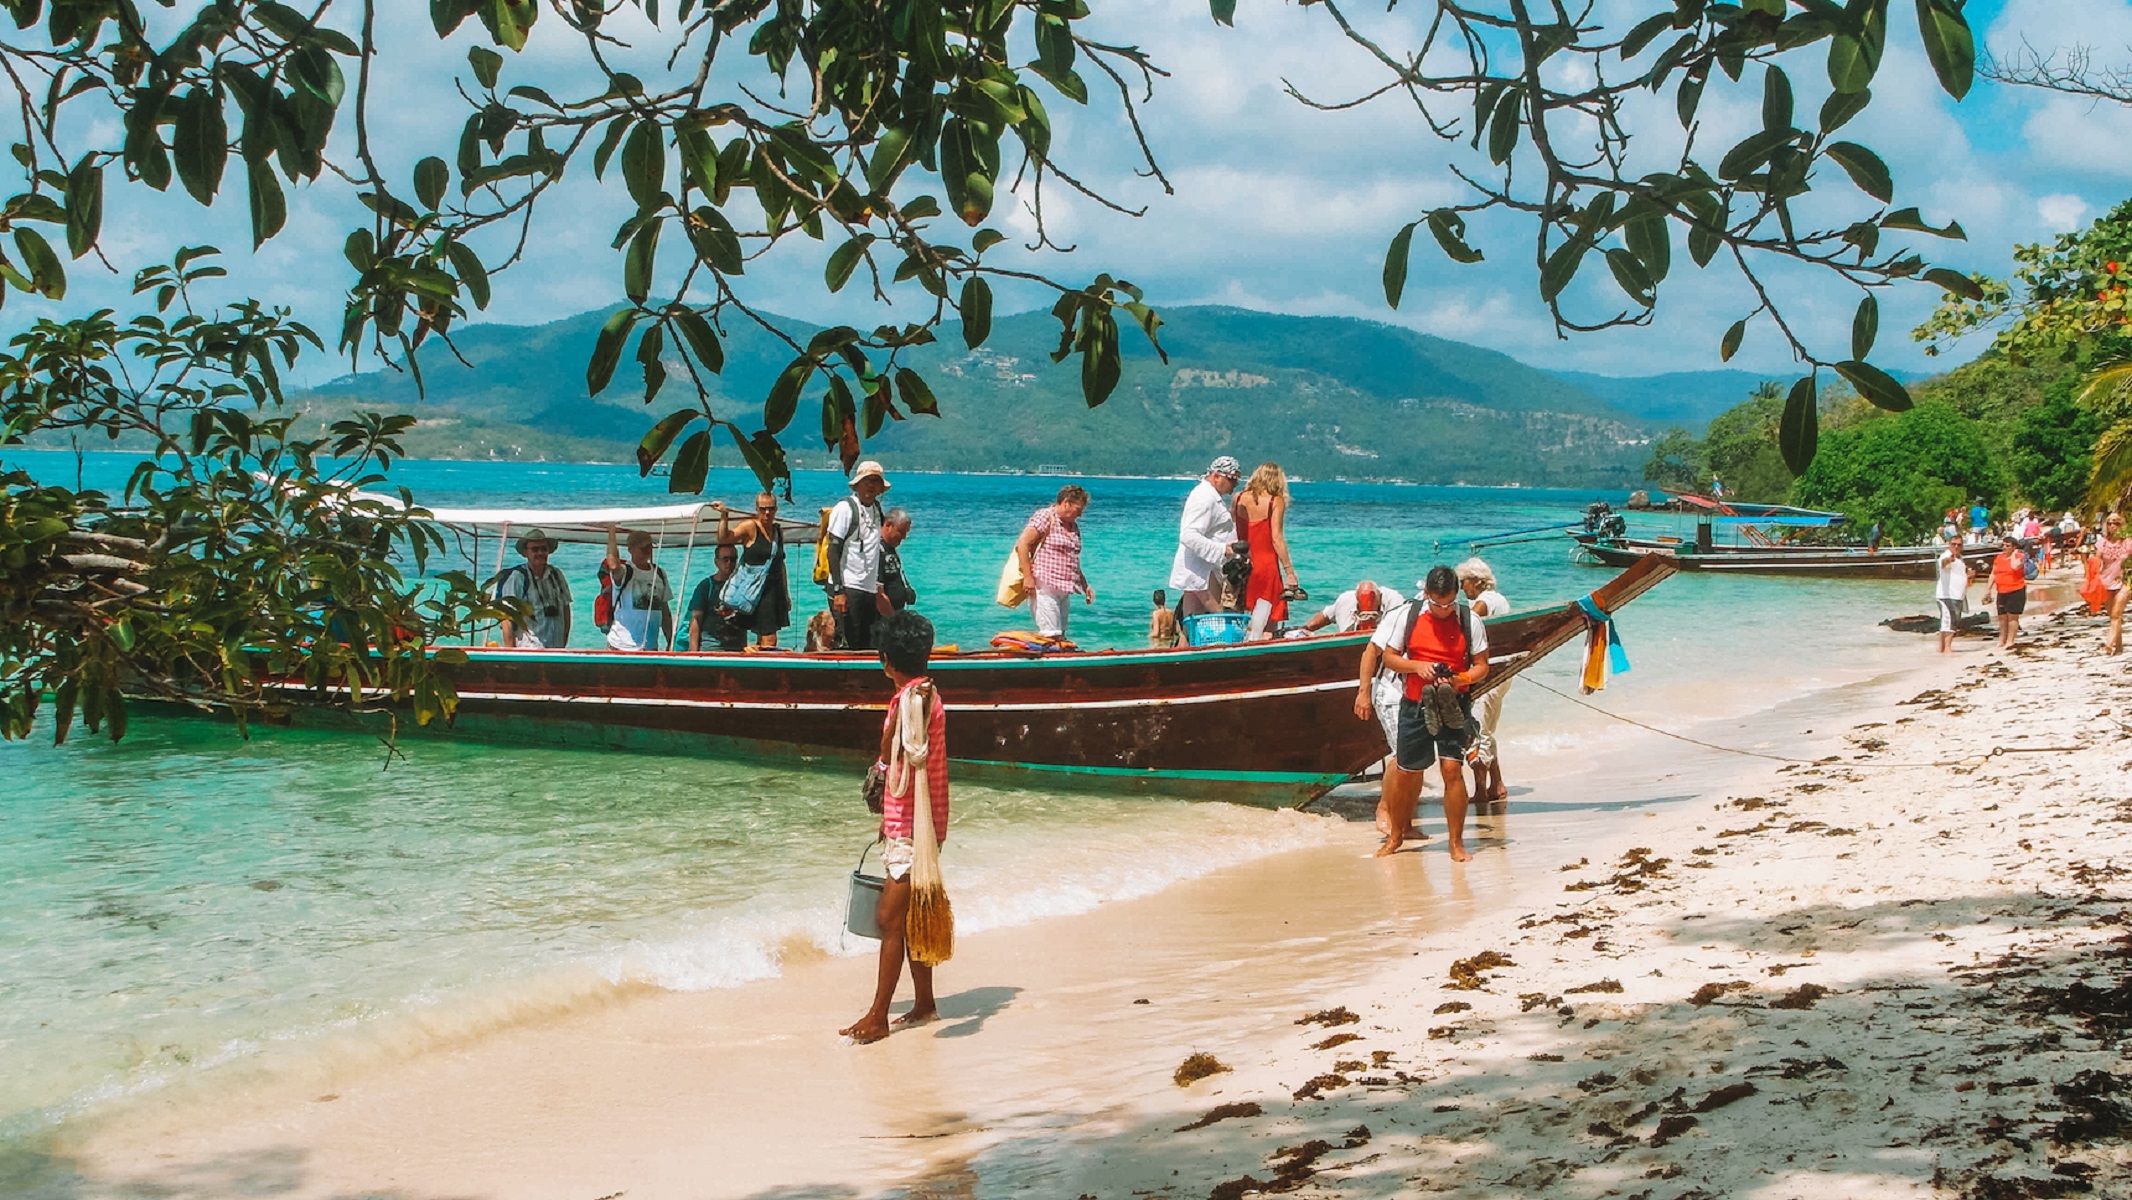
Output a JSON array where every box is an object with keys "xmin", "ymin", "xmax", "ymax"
[{"xmin": 303, "ymin": 307, "xmax": 1688, "ymax": 486}]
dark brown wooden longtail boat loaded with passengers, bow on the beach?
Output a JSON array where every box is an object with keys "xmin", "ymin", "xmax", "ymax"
[{"xmin": 249, "ymin": 554, "xmax": 1674, "ymax": 806}]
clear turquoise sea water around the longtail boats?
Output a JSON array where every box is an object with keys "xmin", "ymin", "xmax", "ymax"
[{"xmin": 0, "ymin": 452, "xmax": 1932, "ymax": 1149}]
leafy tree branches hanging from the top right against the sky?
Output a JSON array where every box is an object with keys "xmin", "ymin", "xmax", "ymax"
[{"xmin": 1321, "ymin": 0, "xmax": 1978, "ymax": 471}]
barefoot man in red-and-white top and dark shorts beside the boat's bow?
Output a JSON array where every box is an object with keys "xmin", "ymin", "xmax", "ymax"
[{"xmin": 1356, "ymin": 567, "xmax": 1488, "ymax": 863}]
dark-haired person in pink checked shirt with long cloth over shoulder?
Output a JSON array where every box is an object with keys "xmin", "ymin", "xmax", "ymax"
[{"xmin": 838, "ymin": 610, "xmax": 947, "ymax": 1047}]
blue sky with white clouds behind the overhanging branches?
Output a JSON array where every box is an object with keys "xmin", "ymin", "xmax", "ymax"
[{"xmin": 16, "ymin": 0, "xmax": 2132, "ymax": 379}]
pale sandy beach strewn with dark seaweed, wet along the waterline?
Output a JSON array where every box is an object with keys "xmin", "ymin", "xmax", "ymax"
[{"xmin": 38, "ymin": 596, "xmax": 2132, "ymax": 1200}]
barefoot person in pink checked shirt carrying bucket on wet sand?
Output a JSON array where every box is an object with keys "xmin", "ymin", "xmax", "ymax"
[{"xmin": 840, "ymin": 610, "xmax": 953, "ymax": 1047}]
